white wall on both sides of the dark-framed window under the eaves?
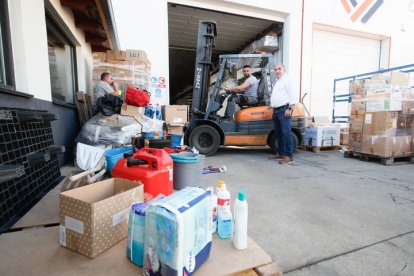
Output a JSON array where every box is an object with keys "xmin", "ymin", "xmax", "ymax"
[{"xmin": 8, "ymin": 0, "xmax": 93, "ymax": 101}]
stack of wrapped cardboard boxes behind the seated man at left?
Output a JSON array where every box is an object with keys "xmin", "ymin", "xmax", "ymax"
[{"xmin": 92, "ymin": 50, "xmax": 151, "ymax": 91}]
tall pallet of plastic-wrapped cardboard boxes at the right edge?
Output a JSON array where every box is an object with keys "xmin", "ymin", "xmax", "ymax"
[{"xmin": 345, "ymin": 71, "xmax": 414, "ymax": 165}]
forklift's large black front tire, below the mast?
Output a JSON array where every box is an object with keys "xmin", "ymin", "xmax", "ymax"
[{"xmin": 190, "ymin": 125, "xmax": 220, "ymax": 155}]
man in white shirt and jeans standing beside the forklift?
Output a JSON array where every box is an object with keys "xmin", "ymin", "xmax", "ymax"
[{"xmin": 270, "ymin": 64, "xmax": 296, "ymax": 165}]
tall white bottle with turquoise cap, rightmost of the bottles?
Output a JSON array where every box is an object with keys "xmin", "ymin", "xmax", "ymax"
[{"xmin": 233, "ymin": 190, "xmax": 249, "ymax": 250}]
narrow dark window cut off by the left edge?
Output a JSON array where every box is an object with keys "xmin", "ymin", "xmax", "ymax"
[{"xmin": 0, "ymin": 0, "xmax": 14, "ymax": 89}]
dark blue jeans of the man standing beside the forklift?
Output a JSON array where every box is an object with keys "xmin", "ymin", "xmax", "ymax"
[{"xmin": 272, "ymin": 105, "xmax": 293, "ymax": 158}]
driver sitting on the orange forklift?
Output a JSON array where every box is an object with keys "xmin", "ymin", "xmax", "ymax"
[{"xmin": 223, "ymin": 65, "xmax": 259, "ymax": 118}]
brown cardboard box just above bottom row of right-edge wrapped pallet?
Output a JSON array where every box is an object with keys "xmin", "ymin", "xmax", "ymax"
[{"xmin": 362, "ymin": 111, "xmax": 398, "ymax": 136}]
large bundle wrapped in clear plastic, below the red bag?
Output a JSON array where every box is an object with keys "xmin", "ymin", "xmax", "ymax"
[{"xmin": 76, "ymin": 114, "xmax": 142, "ymax": 148}]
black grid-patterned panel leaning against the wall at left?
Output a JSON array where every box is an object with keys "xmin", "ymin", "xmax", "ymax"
[{"xmin": 0, "ymin": 108, "xmax": 61, "ymax": 233}]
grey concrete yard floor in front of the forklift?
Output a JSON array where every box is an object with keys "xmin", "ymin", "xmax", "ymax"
[{"xmin": 202, "ymin": 148, "xmax": 414, "ymax": 275}]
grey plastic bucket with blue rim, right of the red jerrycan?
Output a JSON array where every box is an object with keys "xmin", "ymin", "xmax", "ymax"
[{"xmin": 170, "ymin": 152, "xmax": 205, "ymax": 190}]
